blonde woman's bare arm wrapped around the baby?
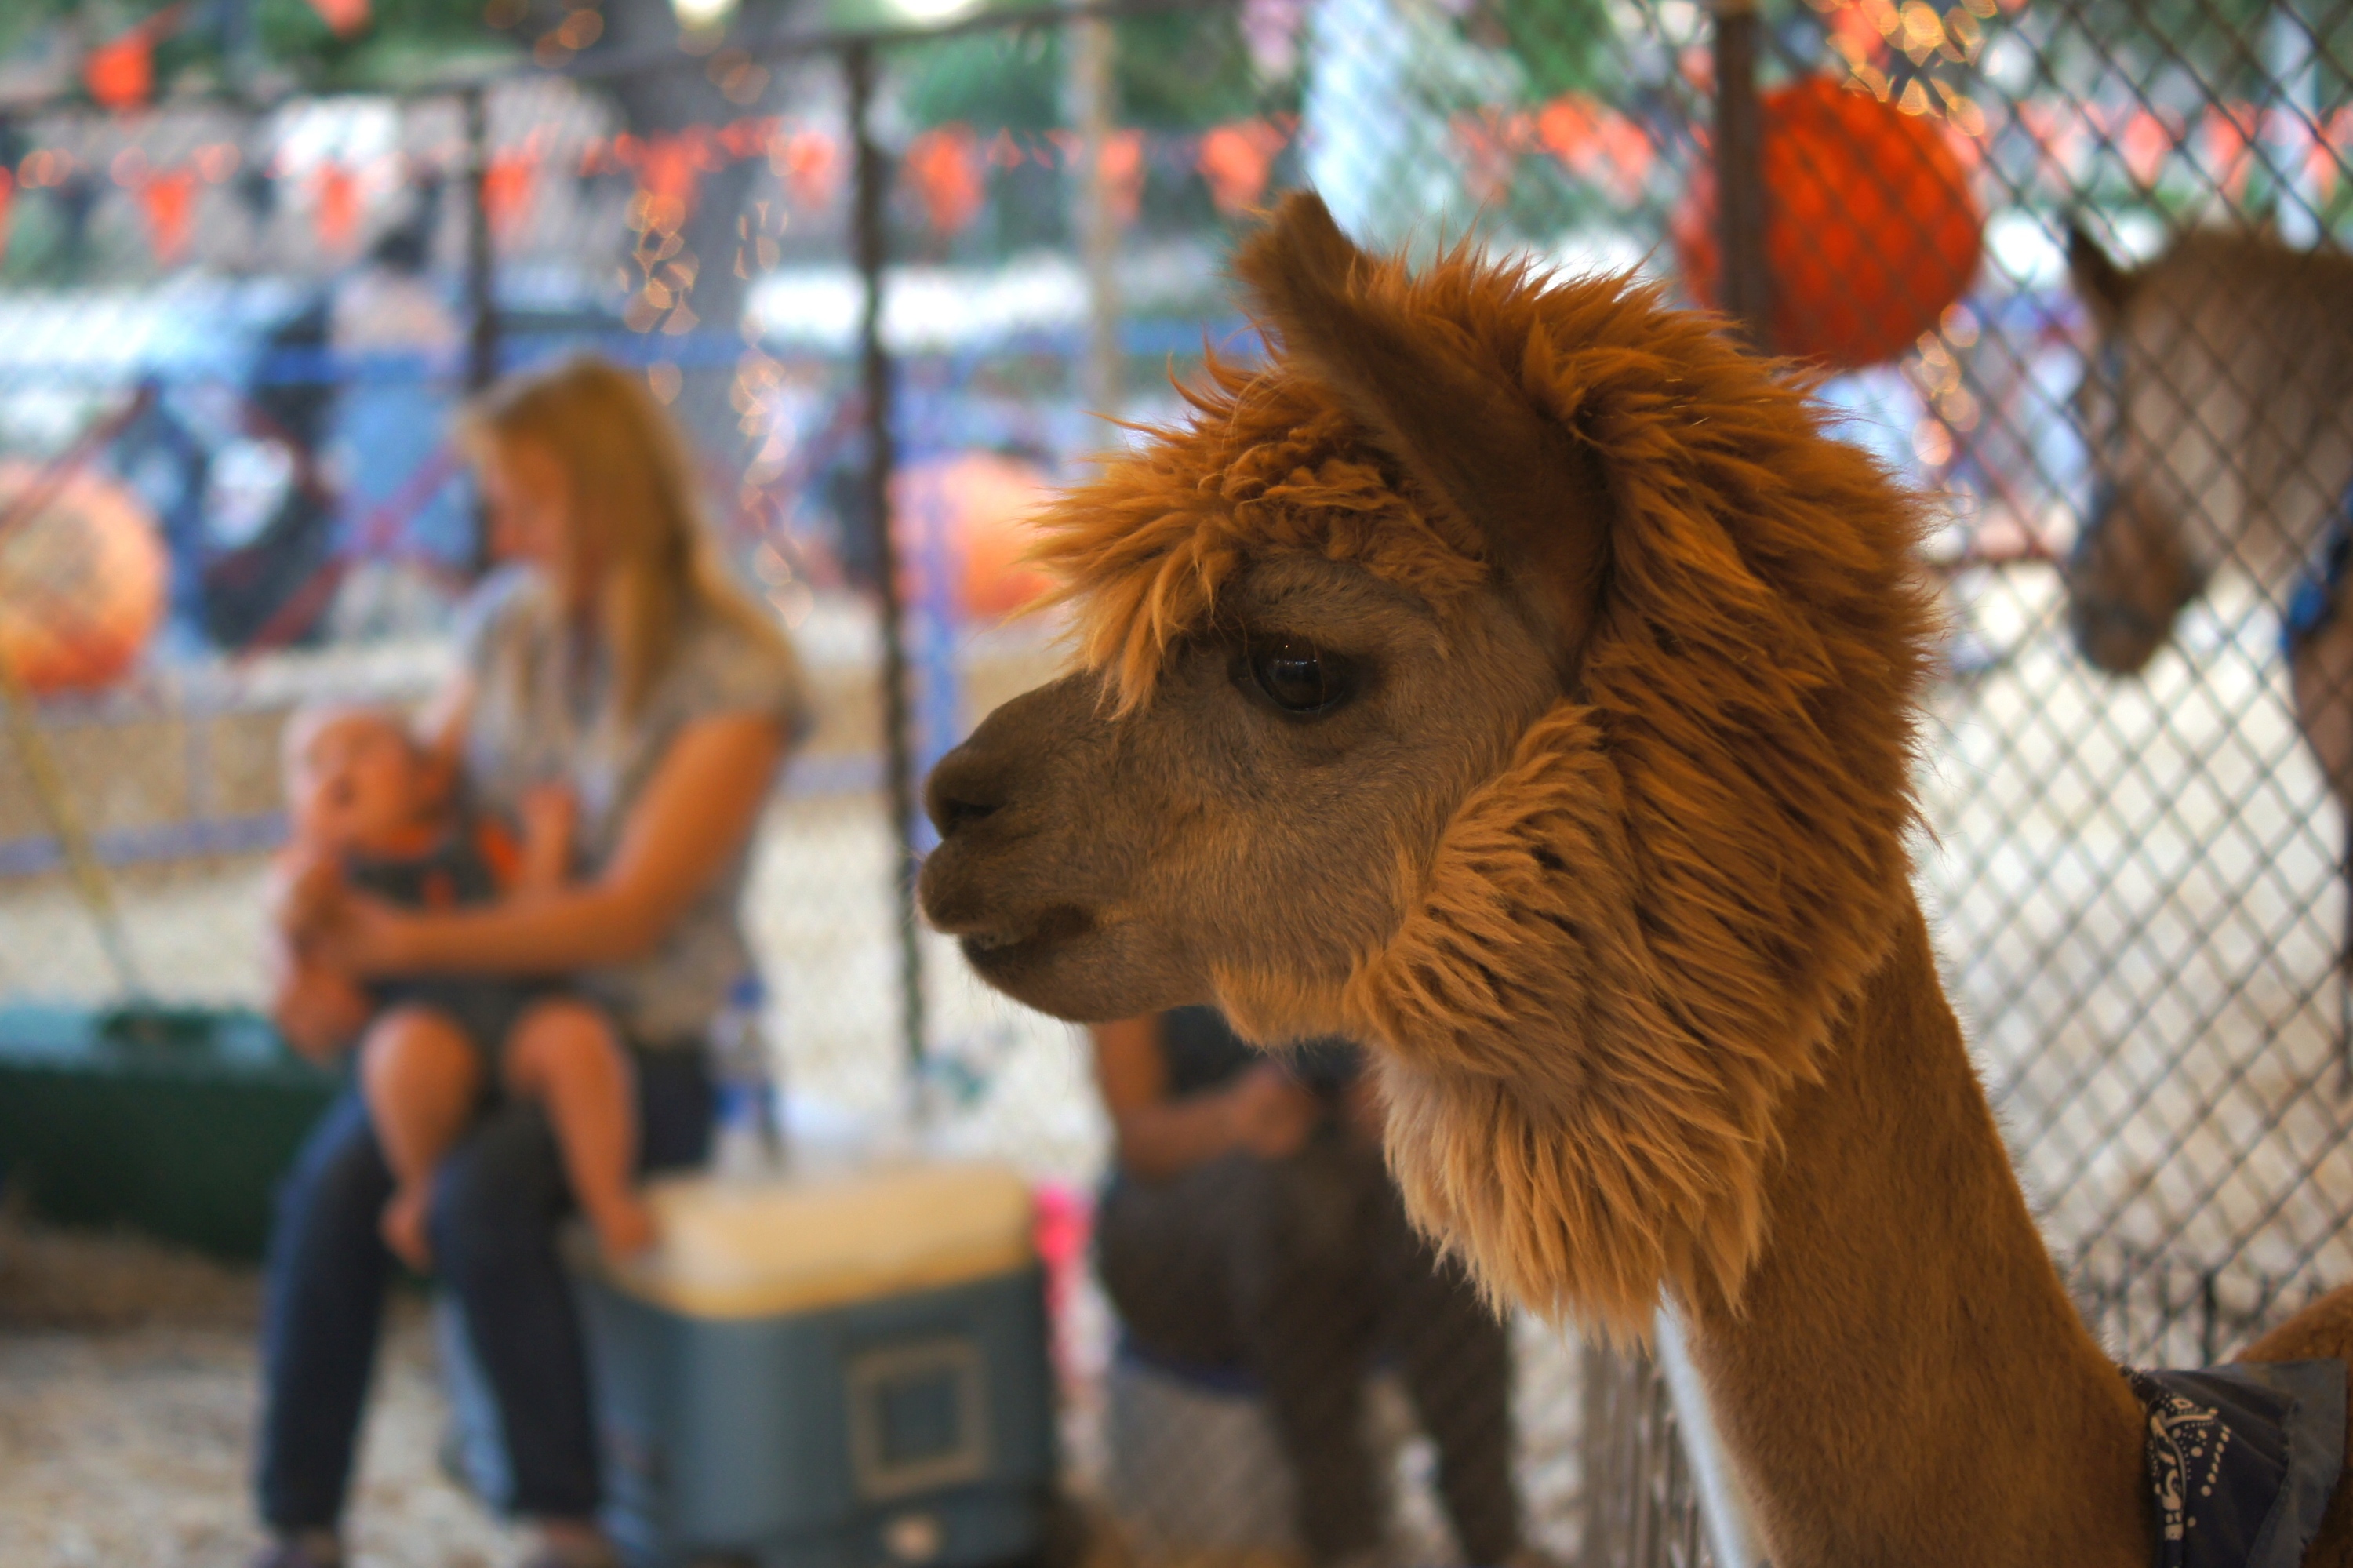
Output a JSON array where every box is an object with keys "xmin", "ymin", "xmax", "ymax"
[{"xmin": 311, "ymin": 715, "xmax": 786, "ymax": 975}]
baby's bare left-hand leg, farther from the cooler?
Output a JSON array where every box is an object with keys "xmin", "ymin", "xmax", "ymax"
[{"xmin": 360, "ymin": 1008, "xmax": 482, "ymax": 1269}]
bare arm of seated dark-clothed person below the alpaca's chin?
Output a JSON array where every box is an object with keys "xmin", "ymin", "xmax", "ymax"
[{"xmin": 1087, "ymin": 1017, "xmax": 1322, "ymax": 1182}]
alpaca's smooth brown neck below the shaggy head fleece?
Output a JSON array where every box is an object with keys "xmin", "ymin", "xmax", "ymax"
[{"xmin": 1687, "ymin": 890, "xmax": 2155, "ymax": 1568}]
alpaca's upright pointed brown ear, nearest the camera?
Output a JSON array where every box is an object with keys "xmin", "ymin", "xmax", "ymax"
[{"xmin": 1233, "ymin": 191, "xmax": 1607, "ymax": 682}]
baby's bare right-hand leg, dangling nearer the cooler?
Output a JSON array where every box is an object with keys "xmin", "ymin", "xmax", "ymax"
[{"xmin": 506, "ymin": 1001, "xmax": 654, "ymax": 1257}]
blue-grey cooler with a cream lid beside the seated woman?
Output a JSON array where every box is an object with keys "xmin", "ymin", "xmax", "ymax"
[{"xmin": 452, "ymin": 1163, "xmax": 1054, "ymax": 1568}]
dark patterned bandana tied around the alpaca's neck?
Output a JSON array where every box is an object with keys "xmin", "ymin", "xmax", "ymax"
[{"xmin": 2125, "ymin": 1361, "xmax": 2346, "ymax": 1568}]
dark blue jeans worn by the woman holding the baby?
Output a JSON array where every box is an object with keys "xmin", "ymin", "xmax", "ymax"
[{"xmin": 256, "ymin": 1050, "xmax": 711, "ymax": 1533}]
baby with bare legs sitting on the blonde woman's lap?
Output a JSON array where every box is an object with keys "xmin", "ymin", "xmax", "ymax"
[{"xmin": 278, "ymin": 706, "xmax": 654, "ymax": 1269}]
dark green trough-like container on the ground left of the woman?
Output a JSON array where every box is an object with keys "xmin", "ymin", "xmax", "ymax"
[{"xmin": 0, "ymin": 1006, "xmax": 341, "ymax": 1260}]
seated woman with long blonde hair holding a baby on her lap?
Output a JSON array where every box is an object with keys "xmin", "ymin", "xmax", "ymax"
[{"xmin": 259, "ymin": 360, "xmax": 805, "ymax": 1568}]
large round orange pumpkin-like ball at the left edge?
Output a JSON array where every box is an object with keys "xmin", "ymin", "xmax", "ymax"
[{"xmin": 0, "ymin": 464, "xmax": 167, "ymax": 694}]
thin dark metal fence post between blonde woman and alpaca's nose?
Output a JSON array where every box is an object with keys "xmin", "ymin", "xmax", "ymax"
[{"xmin": 842, "ymin": 42, "xmax": 925, "ymax": 1071}]
